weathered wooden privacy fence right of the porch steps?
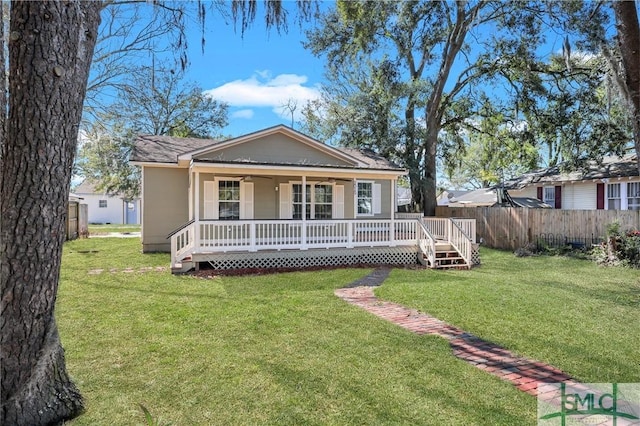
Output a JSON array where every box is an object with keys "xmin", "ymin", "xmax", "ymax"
[{"xmin": 436, "ymin": 206, "xmax": 640, "ymax": 250}]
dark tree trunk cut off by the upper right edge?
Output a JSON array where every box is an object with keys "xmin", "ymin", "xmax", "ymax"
[{"xmin": 612, "ymin": 1, "xmax": 640, "ymax": 173}]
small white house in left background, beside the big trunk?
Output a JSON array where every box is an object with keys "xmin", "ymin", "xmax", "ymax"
[{"xmin": 75, "ymin": 180, "xmax": 140, "ymax": 224}]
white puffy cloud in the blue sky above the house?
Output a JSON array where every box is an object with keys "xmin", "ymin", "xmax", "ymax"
[{"xmin": 204, "ymin": 70, "xmax": 320, "ymax": 119}]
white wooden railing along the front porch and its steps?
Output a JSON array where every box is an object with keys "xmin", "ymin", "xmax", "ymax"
[{"xmin": 171, "ymin": 218, "xmax": 475, "ymax": 267}]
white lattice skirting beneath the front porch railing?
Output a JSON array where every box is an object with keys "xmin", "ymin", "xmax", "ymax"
[{"xmin": 193, "ymin": 247, "xmax": 418, "ymax": 270}]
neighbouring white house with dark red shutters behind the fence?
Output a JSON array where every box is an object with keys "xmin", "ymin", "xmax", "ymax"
[{"xmin": 504, "ymin": 155, "xmax": 640, "ymax": 210}]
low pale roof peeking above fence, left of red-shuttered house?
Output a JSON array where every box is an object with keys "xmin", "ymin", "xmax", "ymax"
[{"xmin": 445, "ymin": 188, "xmax": 550, "ymax": 209}]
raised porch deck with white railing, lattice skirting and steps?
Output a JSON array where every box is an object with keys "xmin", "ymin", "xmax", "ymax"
[{"xmin": 171, "ymin": 214, "xmax": 479, "ymax": 273}]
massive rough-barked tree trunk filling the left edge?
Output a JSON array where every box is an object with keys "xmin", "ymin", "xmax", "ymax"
[{"xmin": 0, "ymin": 0, "xmax": 101, "ymax": 425}]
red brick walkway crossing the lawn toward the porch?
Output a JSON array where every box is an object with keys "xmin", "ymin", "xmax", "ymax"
[{"xmin": 335, "ymin": 269, "xmax": 577, "ymax": 401}]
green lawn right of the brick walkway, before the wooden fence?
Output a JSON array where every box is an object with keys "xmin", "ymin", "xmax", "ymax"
[{"xmin": 376, "ymin": 246, "xmax": 640, "ymax": 383}]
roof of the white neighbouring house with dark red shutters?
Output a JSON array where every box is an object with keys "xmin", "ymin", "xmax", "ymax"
[{"xmin": 504, "ymin": 155, "xmax": 638, "ymax": 189}]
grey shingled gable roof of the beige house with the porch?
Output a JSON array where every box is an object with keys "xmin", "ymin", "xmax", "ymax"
[{"xmin": 130, "ymin": 125, "xmax": 403, "ymax": 171}]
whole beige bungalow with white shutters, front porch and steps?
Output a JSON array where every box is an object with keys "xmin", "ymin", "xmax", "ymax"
[{"xmin": 131, "ymin": 125, "xmax": 475, "ymax": 272}]
